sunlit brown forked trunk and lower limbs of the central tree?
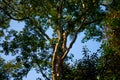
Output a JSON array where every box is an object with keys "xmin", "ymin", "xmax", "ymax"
[{"xmin": 52, "ymin": 9, "xmax": 85, "ymax": 80}]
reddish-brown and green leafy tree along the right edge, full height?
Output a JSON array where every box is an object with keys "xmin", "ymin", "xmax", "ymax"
[{"xmin": 100, "ymin": 0, "xmax": 120, "ymax": 80}]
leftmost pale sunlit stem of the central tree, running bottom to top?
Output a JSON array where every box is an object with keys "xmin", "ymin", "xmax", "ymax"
[{"xmin": 52, "ymin": 0, "xmax": 64, "ymax": 80}]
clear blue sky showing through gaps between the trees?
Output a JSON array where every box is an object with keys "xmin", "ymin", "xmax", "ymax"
[{"xmin": 1, "ymin": 20, "xmax": 100, "ymax": 80}]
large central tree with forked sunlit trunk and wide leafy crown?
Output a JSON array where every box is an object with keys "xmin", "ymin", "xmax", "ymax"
[{"xmin": 0, "ymin": 0, "xmax": 105, "ymax": 80}]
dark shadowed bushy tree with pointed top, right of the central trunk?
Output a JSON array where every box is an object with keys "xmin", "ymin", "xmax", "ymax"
[{"xmin": 61, "ymin": 47, "xmax": 99, "ymax": 80}]
